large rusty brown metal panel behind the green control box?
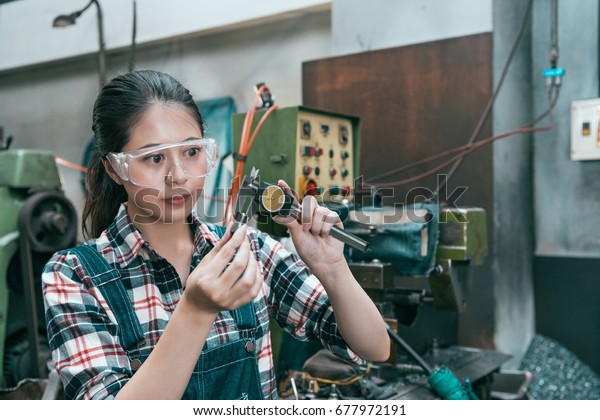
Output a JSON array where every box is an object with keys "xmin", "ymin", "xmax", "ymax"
[{"xmin": 302, "ymin": 33, "xmax": 494, "ymax": 348}]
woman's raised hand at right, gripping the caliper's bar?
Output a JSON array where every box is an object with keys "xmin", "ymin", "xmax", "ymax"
[{"xmin": 274, "ymin": 180, "xmax": 346, "ymax": 271}]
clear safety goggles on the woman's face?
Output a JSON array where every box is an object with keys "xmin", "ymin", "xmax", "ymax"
[{"xmin": 106, "ymin": 138, "xmax": 219, "ymax": 187}]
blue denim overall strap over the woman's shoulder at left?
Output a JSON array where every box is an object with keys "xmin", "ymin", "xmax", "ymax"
[{"xmin": 68, "ymin": 245, "xmax": 144, "ymax": 350}]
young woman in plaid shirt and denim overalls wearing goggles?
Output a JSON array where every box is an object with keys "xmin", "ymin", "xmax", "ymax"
[{"xmin": 42, "ymin": 70, "xmax": 390, "ymax": 399}]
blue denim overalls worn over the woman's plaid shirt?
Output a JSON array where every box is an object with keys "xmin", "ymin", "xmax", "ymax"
[{"xmin": 69, "ymin": 240, "xmax": 264, "ymax": 400}]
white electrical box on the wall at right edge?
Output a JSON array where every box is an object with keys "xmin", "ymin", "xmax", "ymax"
[{"xmin": 571, "ymin": 98, "xmax": 600, "ymax": 160}]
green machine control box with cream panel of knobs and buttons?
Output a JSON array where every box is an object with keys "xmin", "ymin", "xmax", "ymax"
[{"xmin": 232, "ymin": 106, "xmax": 360, "ymax": 234}]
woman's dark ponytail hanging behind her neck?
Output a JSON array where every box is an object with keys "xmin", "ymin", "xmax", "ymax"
[{"xmin": 81, "ymin": 152, "xmax": 127, "ymax": 239}]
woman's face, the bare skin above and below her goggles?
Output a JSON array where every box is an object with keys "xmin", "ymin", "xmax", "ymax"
[{"xmin": 113, "ymin": 103, "xmax": 204, "ymax": 224}]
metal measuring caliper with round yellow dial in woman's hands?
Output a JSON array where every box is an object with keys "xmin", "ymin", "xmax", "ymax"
[{"xmin": 233, "ymin": 168, "xmax": 369, "ymax": 252}]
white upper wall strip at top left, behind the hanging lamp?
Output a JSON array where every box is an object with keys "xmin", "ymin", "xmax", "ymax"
[{"xmin": 0, "ymin": 0, "xmax": 331, "ymax": 71}]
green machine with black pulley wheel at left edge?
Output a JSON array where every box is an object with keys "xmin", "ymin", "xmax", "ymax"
[{"xmin": 0, "ymin": 136, "xmax": 77, "ymax": 399}]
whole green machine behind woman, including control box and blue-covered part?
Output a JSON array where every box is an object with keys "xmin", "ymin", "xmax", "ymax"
[{"xmin": 233, "ymin": 106, "xmax": 511, "ymax": 399}]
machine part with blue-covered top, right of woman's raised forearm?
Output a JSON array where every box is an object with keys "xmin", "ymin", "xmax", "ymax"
[{"xmin": 345, "ymin": 203, "xmax": 511, "ymax": 399}]
